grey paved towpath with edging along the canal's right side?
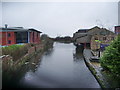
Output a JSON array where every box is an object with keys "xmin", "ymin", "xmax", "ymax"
[{"xmin": 83, "ymin": 49, "xmax": 110, "ymax": 88}]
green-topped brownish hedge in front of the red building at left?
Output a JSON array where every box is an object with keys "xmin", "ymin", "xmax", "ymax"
[{"xmin": 2, "ymin": 45, "xmax": 28, "ymax": 61}]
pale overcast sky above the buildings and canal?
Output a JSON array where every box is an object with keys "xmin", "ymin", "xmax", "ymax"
[{"xmin": 2, "ymin": 2, "xmax": 118, "ymax": 37}]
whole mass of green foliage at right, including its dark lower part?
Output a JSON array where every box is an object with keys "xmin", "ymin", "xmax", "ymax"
[{"xmin": 100, "ymin": 36, "xmax": 120, "ymax": 88}]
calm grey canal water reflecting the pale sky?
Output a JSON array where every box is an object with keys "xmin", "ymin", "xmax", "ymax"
[{"xmin": 3, "ymin": 43, "xmax": 100, "ymax": 88}]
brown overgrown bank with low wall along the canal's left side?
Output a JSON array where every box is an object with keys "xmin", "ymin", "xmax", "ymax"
[{"xmin": 1, "ymin": 38, "xmax": 53, "ymax": 88}]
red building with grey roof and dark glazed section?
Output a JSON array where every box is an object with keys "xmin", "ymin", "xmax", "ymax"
[{"xmin": 0, "ymin": 27, "xmax": 41, "ymax": 46}]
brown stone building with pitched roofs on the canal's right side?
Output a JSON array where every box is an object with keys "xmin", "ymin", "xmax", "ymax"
[{"xmin": 73, "ymin": 26, "xmax": 116, "ymax": 50}]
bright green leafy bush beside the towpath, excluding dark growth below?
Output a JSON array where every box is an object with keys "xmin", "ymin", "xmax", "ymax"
[{"xmin": 100, "ymin": 36, "xmax": 120, "ymax": 76}]
